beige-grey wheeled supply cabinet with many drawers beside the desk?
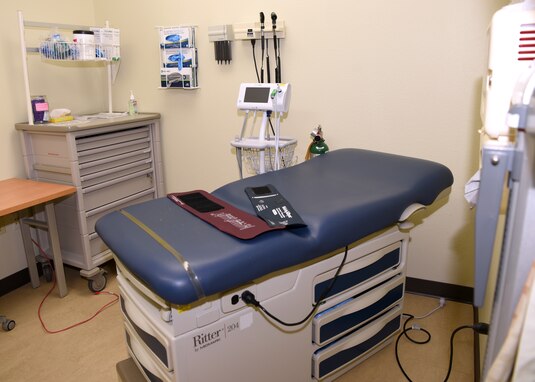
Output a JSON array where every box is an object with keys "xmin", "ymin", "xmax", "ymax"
[{"xmin": 15, "ymin": 113, "xmax": 164, "ymax": 291}]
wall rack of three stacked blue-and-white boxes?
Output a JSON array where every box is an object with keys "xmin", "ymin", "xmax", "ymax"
[{"xmin": 157, "ymin": 26, "xmax": 199, "ymax": 89}]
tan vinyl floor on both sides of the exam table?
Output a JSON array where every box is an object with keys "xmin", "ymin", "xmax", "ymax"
[{"xmin": 0, "ymin": 264, "xmax": 474, "ymax": 382}]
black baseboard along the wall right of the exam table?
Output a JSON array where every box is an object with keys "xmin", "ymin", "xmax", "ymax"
[{"xmin": 405, "ymin": 277, "xmax": 474, "ymax": 305}]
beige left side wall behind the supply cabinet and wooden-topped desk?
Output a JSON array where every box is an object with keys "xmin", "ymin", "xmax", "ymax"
[{"xmin": 0, "ymin": 0, "xmax": 100, "ymax": 279}]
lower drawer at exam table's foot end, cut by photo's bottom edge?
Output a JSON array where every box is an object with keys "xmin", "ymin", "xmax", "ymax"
[{"xmin": 124, "ymin": 321, "xmax": 174, "ymax": 382}]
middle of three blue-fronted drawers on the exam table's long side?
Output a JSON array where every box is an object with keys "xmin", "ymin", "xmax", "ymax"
[{"xmin": 312, "ymin": 275, "xmax": 405, "ymax": 346}]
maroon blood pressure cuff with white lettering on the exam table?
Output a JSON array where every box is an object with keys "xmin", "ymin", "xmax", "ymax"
[{"xmin": 167, "ymin": 190, "xmax": 284, "ymax": 240}]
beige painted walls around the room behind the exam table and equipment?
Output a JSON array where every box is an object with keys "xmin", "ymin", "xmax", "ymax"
[{"xmin": 0, "ymin": 0, "xmax": 507, "ymax": 286}]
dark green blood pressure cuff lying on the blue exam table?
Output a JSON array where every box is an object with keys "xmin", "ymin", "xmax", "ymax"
[{"xmin": 245, "ymin": 184, "xmax": 306, "ymax": 228}]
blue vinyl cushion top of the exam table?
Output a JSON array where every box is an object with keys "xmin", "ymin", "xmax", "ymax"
[{"xmin": 96, "ymin": 149, "xmax": 453, "ymax": 305}]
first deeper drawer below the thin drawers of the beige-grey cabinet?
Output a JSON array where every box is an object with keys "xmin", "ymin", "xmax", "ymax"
[{"xmin": 82, "ymin": 170, "xmax": 153, "ymax": 211}]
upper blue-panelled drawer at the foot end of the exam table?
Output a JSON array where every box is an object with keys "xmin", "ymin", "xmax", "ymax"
[{"xmin": 119, "ymin": 285, "xmax": 174, "ymax": 372}]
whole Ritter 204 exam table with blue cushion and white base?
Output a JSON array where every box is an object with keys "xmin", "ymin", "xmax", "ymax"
[{"xmin": 96, "ymin": 149, "xmax": 453, "ymax": 382}]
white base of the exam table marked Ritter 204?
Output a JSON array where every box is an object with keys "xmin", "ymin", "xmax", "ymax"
[{"xmin": 117, "ymin": 228, "xmax": 408, "ymax": 382}]
